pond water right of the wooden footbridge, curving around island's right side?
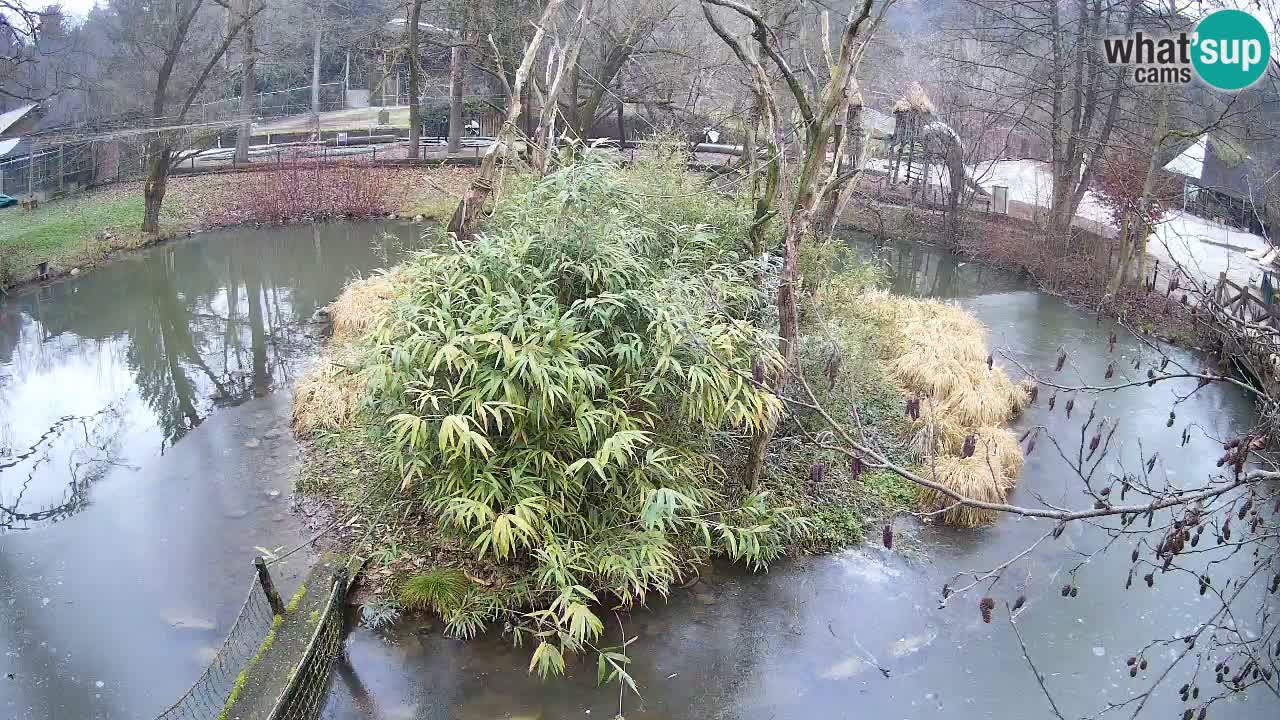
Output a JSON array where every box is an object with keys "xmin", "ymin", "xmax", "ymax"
[{"xmin": 317, "ymin": 237, "xmax": 1280, "ymax": 720}]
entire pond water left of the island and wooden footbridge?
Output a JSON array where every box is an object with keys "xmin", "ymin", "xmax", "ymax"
[{"xmin": 0, "ymin": 223, "xmax": 419, "ymax": 720}]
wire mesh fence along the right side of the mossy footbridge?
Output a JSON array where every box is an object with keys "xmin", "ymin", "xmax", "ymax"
[{"xmin": 270, "ymin": 569, "xmax": 351, "ymax": 720}]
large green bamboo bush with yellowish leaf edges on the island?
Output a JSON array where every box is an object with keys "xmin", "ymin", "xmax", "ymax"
[{"xmin": 355, "ymin": 159, "xmax": 803, "ymax": 674}]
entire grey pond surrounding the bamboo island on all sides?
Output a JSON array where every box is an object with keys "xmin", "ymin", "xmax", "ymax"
[{"xmin": 0, "ymin": 223, "xmax": 1276, "ymax": 720}]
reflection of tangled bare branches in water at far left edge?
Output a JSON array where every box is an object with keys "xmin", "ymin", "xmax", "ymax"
[{"xmin": 0, "ymin": 405, "xmax": 124, "ymax": 532}]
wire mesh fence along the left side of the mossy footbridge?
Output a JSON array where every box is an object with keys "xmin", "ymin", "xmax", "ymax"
[{"xmin": 157, "ymin": 578, "xmax": 274, "ymax": 720}]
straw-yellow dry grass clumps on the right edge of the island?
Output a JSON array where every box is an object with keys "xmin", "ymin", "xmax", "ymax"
[{"xmin": 858, "ymin": 291, "xmax": 1029, "ymax": 527}]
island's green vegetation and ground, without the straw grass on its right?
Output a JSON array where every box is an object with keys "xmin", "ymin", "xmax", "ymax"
[{"xmin": 294, "ymin": 147, "xmax": 1029, "ymax": 675}]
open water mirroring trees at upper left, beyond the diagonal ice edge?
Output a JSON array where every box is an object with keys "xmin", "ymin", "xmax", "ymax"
[{"xmin": 0, "ymin": 224, "xmax": 417, "ymax": 530}]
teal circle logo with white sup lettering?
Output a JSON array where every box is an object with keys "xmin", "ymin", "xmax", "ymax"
[{"xmin": 1192, "ymin": 10, "xmax": 1271, "ymax": 90}]
